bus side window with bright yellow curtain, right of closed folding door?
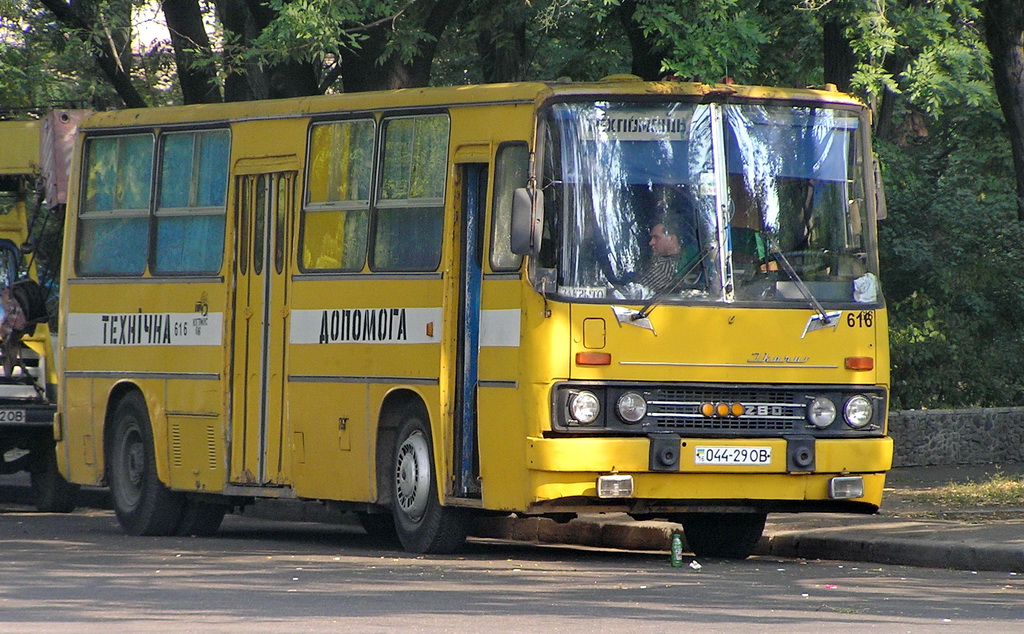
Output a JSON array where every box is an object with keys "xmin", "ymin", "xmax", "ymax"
[{"xmin": 301, "ymin": 119, "xmax": 375, "ymax": 271}]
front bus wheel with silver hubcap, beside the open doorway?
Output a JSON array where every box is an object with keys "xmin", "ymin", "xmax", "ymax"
[{"xmin": 391, "ymin": 416, "xmax": 470, "ymax": 554}]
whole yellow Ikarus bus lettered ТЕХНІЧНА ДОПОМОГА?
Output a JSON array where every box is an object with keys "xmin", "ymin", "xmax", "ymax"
[{"xmin": 54, "ymin": 76, "xmax": 892, "ymax": 557}]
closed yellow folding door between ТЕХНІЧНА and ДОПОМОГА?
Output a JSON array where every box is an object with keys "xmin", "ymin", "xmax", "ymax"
[{"xmin": 230, "ymin": 171, "xmax": 296, "ymax": 485}]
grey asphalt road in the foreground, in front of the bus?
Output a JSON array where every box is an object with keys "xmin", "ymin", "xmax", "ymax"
[{"xmin": 0, "ymin": 501, "xmax": 1024, "ymax": 633}]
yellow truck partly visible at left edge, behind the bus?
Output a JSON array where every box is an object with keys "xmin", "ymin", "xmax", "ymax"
[{"xmin": 0, "ymin": 120, "xmax": 76, "ymax": 512}]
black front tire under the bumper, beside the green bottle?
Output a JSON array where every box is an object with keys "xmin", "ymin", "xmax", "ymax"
[{"xmin": 678, "ymin": 513, "xmax": 768, "ymax": 559}]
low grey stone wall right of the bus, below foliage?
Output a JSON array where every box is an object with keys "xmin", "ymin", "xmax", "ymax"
[{"xmin": 889, "ymin": 408, "xmax": 1024, "ymax": 467}]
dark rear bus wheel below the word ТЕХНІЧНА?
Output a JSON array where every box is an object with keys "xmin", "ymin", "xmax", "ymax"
[{"xmin": 106, "ymin": 392, "xmax": 184, "ymax": 535}]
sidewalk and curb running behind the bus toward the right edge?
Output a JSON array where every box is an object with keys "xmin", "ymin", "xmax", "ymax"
[{"xmin": 477, "ymin": 464, "xmax": 1024, "ymax": 573}]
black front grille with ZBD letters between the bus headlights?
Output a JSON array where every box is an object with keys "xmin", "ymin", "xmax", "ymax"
[{"xmin": 647, "ymin": 388, "xmax": 807, "ymax": 433}]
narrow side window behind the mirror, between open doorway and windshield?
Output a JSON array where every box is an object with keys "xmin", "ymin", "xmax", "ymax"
[{"xmin": 490, "ymin": 141, "xmax": 529, "ymax": 270}]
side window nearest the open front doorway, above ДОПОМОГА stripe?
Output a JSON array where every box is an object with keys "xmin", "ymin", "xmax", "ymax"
[{"xmin": 372, "ymin": 115, "xmax": 449, "ymax": 270}]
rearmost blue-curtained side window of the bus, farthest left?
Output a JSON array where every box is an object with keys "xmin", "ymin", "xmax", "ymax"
[{"xmin": 76, "ymin": 133, "xmax": 153, "ymax": 276}]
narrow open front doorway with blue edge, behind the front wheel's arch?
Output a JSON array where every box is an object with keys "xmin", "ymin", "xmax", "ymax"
[{"xmin": 454, "ymin": 163, "xmax": 487, "ymax": 498}]
